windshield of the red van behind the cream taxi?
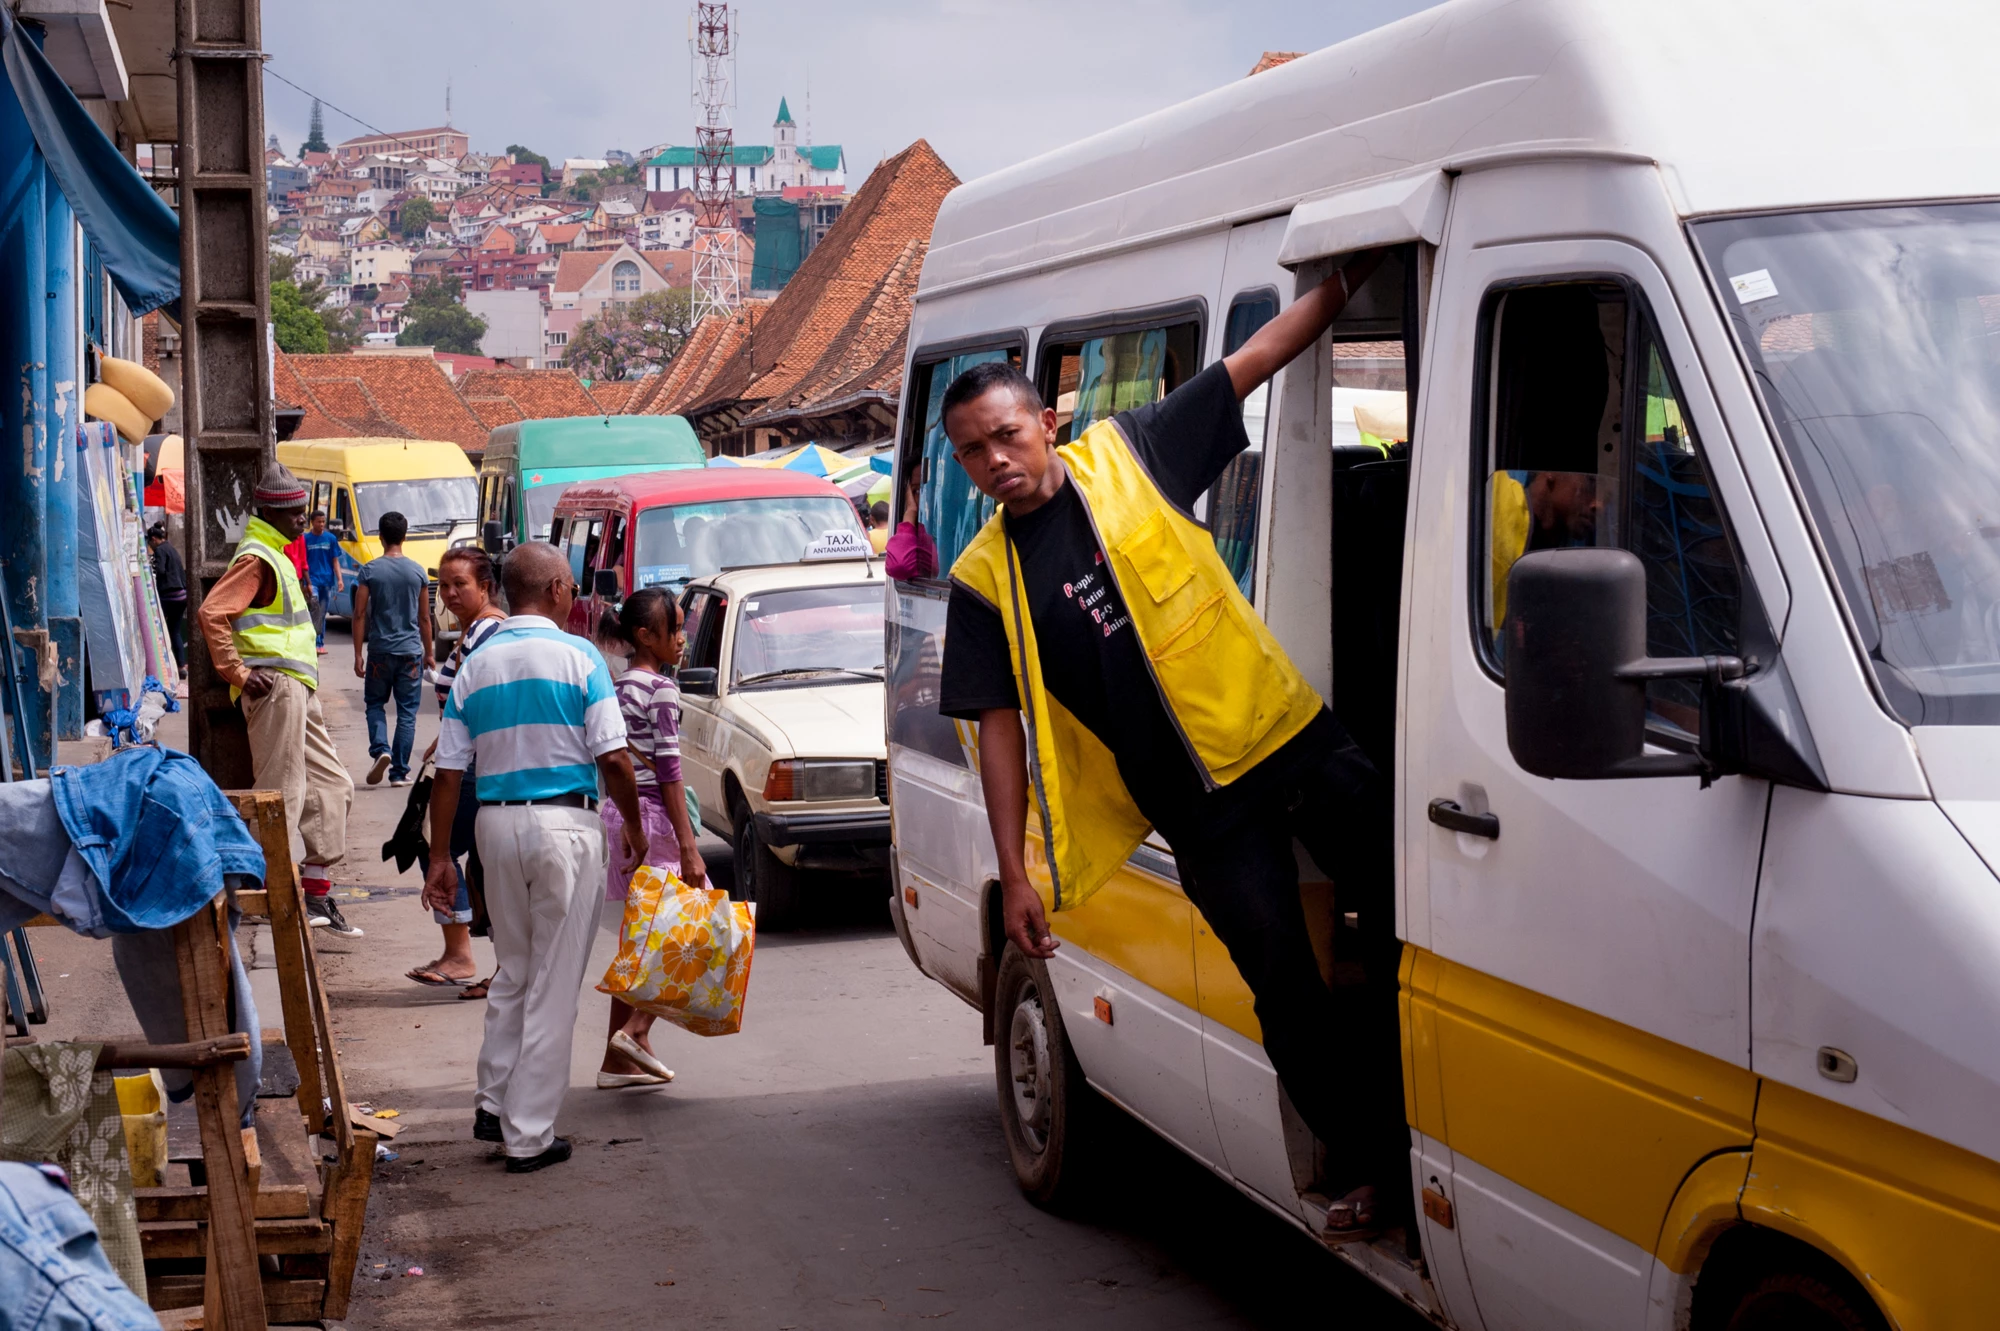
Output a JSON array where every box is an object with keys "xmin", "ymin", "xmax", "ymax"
[{"xmin": 632, "ymin": 492, "xmax": 880, "ymax": 587}]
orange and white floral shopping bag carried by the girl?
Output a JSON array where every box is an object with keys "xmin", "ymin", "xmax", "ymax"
[{"xmin": 598, "ymin": 865, "xmax": 756, "ymax": 1035}]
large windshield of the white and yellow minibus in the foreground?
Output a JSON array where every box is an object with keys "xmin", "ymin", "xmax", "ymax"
[{"xmin": 1694, "ymin": 204, "xmax": 2000, "ymax": 725}]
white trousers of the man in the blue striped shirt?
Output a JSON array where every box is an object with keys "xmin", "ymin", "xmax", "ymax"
[{"xmin": 474, "ymin": 803, "xmax": 604, "ymax": 1157}]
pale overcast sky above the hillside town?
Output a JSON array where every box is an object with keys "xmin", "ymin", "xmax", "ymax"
[{"xmin": 264, "ymin": 0, "xmax": 1426, "ymax": 188}]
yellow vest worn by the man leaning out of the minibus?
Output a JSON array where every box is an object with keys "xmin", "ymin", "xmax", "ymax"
[{"xmin": 952, "ymin": 420, "xmax": 1324, "ymax": 911}]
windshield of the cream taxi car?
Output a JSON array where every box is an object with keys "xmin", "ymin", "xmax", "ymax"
[{"xmin": 730, "ymin": 582, "xmax": 882, "ymax": 685}]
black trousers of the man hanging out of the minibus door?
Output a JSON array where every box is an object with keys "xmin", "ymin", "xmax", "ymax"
[{"xmin": 1162, "ymin": 731, "xmax": 1410, "ymax": 1191}]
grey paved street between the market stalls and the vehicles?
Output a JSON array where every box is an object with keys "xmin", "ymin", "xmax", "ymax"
[{"xmin": 36, "ymin": 634, "xmax": 1424, "ymax": 1331}]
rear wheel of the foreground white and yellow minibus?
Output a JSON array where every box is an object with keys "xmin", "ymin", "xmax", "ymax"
[{"xmin": 994, "ymin": 943, "xmax": 1104, "ymax": 1209}]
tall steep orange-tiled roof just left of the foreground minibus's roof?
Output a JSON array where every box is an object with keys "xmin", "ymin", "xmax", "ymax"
[{"xmin": 688, "ymin": 140, "xmax": 958, "ymax": 427}]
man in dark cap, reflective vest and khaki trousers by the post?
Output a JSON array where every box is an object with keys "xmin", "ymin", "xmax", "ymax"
[{"xmin": 196, "ymin": 462, "xmax": 362, "ymax": 937}]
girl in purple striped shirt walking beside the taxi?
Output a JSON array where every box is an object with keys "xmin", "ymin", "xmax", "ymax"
[{"xmin": 598, "ymin": 588, "xmax": 708, "ymax": 1091}]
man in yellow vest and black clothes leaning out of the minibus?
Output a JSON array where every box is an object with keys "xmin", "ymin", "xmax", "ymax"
[{"xmin": 938, "ymin": 256, "xmax": 1408, "ymax": 1237}]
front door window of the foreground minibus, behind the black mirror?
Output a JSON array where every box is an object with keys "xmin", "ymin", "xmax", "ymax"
[{"xmin": 1476, "ymin": 282, "xmax": 1742, "ymax": 743}]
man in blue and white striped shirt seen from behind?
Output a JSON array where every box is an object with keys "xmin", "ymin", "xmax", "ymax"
[{"xmin": 424, "ymin": 544, "xmax": 646, "ymax": 1173}]
